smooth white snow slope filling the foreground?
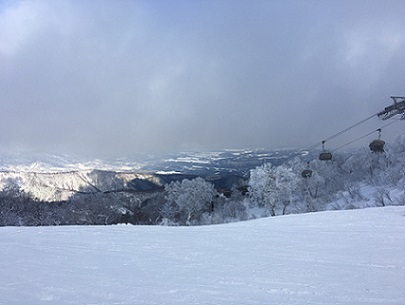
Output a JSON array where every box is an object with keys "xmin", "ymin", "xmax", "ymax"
[{"xmin": 0, "ymin": 206, "xmax": 405, "ymax": 305}]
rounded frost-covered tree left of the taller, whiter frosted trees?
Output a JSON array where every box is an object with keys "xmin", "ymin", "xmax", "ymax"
[{"xmin": 162, "ymin": 177, "xmax": 216, "ymax": 225}]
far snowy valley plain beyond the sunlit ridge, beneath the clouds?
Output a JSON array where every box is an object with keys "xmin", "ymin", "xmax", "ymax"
[{"xmin": 0, "ymin": 149, "xmax": 298, "ymax": 176}]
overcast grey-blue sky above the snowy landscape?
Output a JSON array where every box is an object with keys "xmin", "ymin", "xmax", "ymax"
[{"xmin": 0, "ymin": 0, "xmax": 405, "ymax": 157}]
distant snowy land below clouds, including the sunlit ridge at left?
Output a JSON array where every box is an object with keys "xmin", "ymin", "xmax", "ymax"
[{"xmin": 0, "ymin": 150, "xmax": 302, "ymax": 201}]
